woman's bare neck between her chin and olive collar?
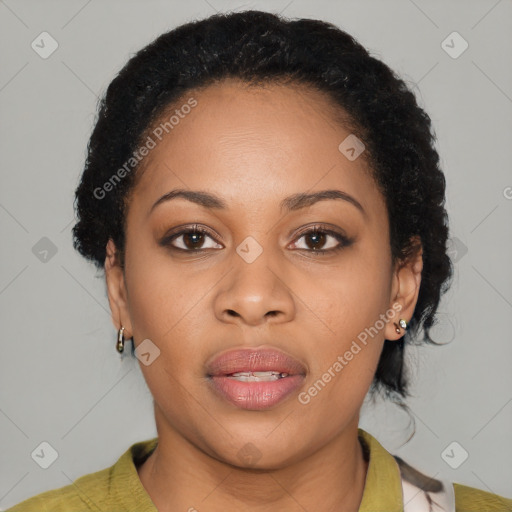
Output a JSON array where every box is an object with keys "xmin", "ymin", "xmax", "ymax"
[{"xmin": 137, "ymin": 408, "xmax": 368, "ymax": 512}]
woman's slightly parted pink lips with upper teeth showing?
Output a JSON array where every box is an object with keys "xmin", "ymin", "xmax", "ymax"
[{"xmin": 206, "ymin": 348, "xmax": 307, "ymax": 411}]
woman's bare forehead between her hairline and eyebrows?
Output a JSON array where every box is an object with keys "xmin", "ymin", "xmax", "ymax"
[{"xmin": 130, "ymin": 79, "xmax": 382, "ymax": 216}]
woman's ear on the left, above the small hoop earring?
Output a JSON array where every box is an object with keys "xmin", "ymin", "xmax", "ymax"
[{"xmin": 105, "ymin": 239, "xmax": 133, "ymax": 339}]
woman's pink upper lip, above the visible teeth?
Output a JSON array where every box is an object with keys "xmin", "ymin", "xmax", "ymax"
[{"xmin": 206, "ymin": 348, "xmax": 306, "ymax": 376}]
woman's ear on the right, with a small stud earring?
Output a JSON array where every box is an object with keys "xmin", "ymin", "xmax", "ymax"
[{"xmin": 385, "ymin": 237, "xmax": 423, "ymax": 340}]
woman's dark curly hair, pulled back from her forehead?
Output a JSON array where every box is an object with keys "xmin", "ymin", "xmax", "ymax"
[{"xmin": 73, "ymin": 10, "xmax": 453, "ymax": 414}]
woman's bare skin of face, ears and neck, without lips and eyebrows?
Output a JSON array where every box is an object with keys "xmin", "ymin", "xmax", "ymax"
[{"xmin": 105, "ymin": 79, "xmax": 422, "ymax": 512}]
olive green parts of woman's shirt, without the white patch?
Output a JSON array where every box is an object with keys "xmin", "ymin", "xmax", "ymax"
[{"xmin": 7, "ymin": 429, "xmax": 512, "ymax": 512}]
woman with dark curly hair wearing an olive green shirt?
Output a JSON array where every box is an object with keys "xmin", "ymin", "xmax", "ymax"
[{"xmin": 11, "ymin": 11, "xmax": 512, "ymax": 512}]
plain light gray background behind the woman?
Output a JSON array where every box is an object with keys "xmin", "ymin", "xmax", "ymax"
[{"xmin": 0, "ymin": 0, "xmax": 512, "ymax": 509}]
